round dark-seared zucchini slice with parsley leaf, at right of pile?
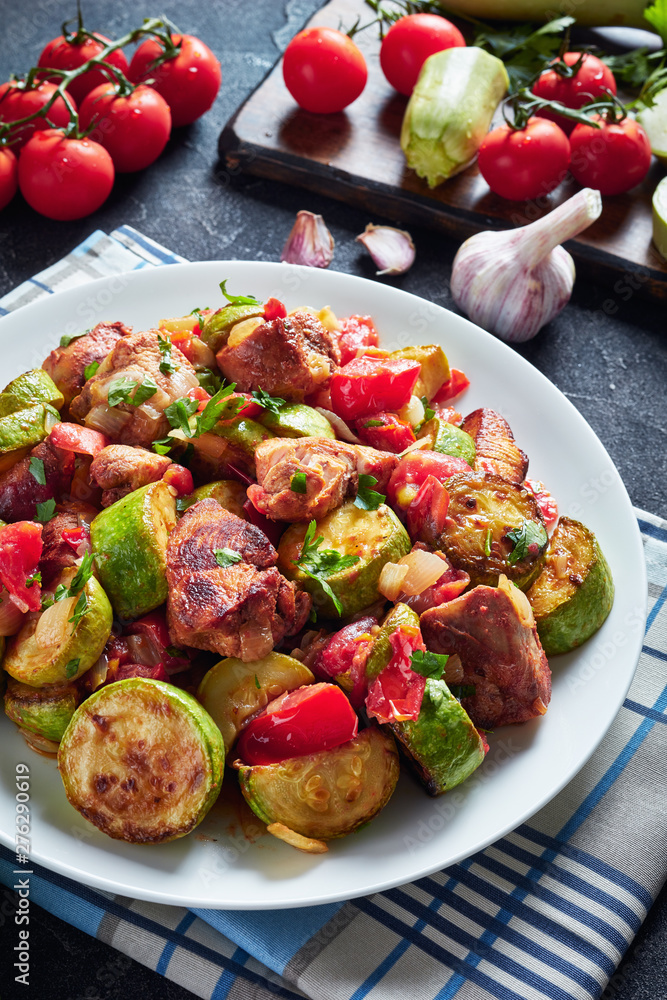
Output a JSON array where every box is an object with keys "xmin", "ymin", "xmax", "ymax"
[{"xmin": 438, "ymin": 472, "xmax": 548, "ymax": 590}]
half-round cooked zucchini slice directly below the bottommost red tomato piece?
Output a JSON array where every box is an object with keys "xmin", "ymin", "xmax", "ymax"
[{"xmin": 239, "ymin": 726, "xmax": 399, "ymax": 840}]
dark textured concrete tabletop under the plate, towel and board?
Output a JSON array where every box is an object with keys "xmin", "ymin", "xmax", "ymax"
[{"xmin": 0, "ymin": 0, "xmax": 667, "ymax": 1000}]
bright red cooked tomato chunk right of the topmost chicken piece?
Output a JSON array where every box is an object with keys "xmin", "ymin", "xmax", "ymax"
[{"xmin": 329, "ymin": 355, "xmax": 421, "ymax": 420}]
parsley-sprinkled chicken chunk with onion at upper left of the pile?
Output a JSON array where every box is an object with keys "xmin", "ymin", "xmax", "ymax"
[{"xmin": 70, "ymin": 330, "xmax": 199, "ymax": 448}]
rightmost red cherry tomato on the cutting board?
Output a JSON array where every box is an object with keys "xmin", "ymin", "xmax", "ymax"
[{"xmin": 570, "ymin": 115, "xmax": 651, "ymax": 194}]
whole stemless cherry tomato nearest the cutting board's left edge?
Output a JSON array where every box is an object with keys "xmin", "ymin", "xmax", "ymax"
[{"xmin": 283, "ymin": 28, "xmax": 368, "ymax": 115}]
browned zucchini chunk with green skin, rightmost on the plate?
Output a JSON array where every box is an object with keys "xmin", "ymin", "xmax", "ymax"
[{"xmin": 527, "ymin": 517, "xmax": 614, "ymax": 656}]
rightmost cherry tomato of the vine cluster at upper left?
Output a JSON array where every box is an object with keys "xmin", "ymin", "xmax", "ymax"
[{"xmin": 129, "ymin": 35, "xmax": 222, "ymax": 127}]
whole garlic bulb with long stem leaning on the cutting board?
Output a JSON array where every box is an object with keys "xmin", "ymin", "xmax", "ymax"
[{"xmin": 451, "ymin": 188, "xmax": 602, "ymax": 343}]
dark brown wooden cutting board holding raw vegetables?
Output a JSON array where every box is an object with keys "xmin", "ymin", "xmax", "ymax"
[{"xmin": 219, "ymin": 0, "xmax": 667, "ymax": 300}]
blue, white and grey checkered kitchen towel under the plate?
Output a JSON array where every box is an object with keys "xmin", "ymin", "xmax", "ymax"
[{"xmin": 0, "ymin": 226, "xmax": 667, "ymax": 1000}]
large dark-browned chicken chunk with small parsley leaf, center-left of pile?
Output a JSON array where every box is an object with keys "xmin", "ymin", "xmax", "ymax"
[{"xmin": 167, "ymin": 499, "xmax": 311, "ymax": 662}]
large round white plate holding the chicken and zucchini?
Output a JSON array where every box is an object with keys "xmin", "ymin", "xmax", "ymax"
[{"xmin": 0, "ymin": 261, "xmax": 646, "ymax": 909}]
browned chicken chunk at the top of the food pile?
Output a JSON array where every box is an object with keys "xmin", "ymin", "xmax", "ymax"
[{"xmin": 216, "ymin": 312, "xmax": 340, "ymax": 403}]
